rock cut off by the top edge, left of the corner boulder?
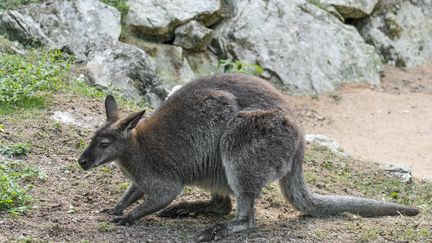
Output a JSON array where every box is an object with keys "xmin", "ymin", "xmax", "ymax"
[{"xmin": 318, "ymin": 0, "xmax": 378, "ymax": 19}]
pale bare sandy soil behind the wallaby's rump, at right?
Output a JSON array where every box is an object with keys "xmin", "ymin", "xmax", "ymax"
[{"xmin": 292, "ymin": 65, "xmax": 432, "ymax": 179}]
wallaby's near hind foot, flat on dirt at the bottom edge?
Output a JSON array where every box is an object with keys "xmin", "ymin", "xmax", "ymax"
[{"xmin": 195, "ymin": 220, "xmax": 255, "ymax": 242}]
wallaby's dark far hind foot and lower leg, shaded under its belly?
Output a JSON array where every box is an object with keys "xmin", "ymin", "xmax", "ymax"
[{"xmin": 159, "ymin": 194, "xmax": 232, "ymax": 218}]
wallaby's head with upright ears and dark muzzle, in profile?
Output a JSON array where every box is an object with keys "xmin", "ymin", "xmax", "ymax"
[{"xmin": 78, "ymin": 95, "xmax": 145, "ymax": 170}]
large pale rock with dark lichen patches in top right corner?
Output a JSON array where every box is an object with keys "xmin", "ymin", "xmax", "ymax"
[{"xmin": 356, "ymin": 0, "xmax": 432, "ymax": 67}]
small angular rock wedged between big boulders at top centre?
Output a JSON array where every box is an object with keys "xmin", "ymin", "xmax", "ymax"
[{"xmin": 174, "ymin": 20, "xmax": 213, "ymax": 51}]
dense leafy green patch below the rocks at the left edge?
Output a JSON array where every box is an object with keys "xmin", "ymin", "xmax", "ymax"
[{"xmin": 0, "ymin": 50, "xmax": 70, "ymax": 113}]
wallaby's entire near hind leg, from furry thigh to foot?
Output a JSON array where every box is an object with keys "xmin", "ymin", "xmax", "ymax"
[{"xmin": 196, "ymin": 111, "xmax": 298, "ymax": 241}]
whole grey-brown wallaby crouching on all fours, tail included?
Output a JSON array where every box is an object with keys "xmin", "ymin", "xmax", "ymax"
[{"xmin": 79, "ymin": 74, "xmax": 419, "ymax": 241}]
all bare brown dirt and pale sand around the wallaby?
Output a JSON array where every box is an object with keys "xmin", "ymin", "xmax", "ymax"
[{"xmin": 0, "ymin": 64, "xmax": 432, "ymax": 242}]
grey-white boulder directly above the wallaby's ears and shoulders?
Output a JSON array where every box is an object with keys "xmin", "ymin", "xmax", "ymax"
[{"xmin": 86, "ymin": 42, "xmax": 168, "ymax": 107}]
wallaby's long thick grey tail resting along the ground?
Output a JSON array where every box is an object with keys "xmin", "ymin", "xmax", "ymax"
[{"xmin": 279, "ymin": 141, "xmax": 419, "ymax": 217}]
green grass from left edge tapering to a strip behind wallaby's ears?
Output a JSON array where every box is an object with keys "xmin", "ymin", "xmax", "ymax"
[{"xmin": 0, "ymin": 47, "xmax": 148, "ymax": 115}]
